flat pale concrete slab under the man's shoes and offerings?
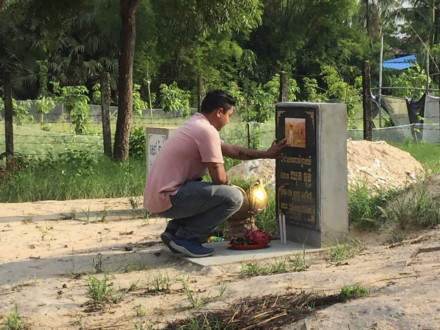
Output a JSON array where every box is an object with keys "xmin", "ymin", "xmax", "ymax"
[{"xmin": 182, "ymin": 240, "xmax": 320, "ymax": 266}]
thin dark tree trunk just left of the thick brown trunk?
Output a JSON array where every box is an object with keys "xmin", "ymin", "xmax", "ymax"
[{"xmin": 100, "ymin": 72, "xmax": 112, "ymax": 158}]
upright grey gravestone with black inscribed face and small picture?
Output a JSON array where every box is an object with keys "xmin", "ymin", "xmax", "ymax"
[{"xmin": 276, "ymin": 102, "xmax": 348, "ymax": 247}]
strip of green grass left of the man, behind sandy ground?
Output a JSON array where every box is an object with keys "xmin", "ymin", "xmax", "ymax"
[{"xmin": 0, "ymin": 151, "xmax": 146, "ymax": 202}]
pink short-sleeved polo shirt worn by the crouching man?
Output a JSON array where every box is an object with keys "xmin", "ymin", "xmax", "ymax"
[{"xmin": 144, "ymin": 112, "xmax": 223, "ymax": 213}]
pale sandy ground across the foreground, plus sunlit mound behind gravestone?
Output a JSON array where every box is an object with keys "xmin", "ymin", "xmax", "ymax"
[{"xmin": 0, "ymin": 141, "xmax": 440, "ymax": 329}]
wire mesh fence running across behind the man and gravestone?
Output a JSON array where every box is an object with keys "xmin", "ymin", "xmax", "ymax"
[{"xmin": 0, "ymin": 105, "xmax": 440, "ymax": 156}]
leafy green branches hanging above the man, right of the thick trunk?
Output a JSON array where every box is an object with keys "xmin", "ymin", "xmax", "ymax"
[{"xmin": 143, "ymin": 0, "xmax": 262, "ymax": 87}]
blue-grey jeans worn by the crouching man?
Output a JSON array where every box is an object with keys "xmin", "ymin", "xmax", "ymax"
[{"xmin": 160, "ymin": 181, "xmax": 243, "ymax": 241}]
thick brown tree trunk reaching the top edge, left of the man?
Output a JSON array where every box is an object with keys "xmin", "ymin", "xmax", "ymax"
[{"xmin": 113, "ymin": 0, "xmax": 139, "ymax": 160}]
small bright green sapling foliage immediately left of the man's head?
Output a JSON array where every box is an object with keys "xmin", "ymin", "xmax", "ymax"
[{"xmin": 160, "ymin": 81, "xmax": 191, "ymax": 117}]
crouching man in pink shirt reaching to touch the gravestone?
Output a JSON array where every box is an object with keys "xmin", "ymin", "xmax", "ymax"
[{"xmin": 144, "ymin": 90, "xmax": 286, "ymax": 257}]
